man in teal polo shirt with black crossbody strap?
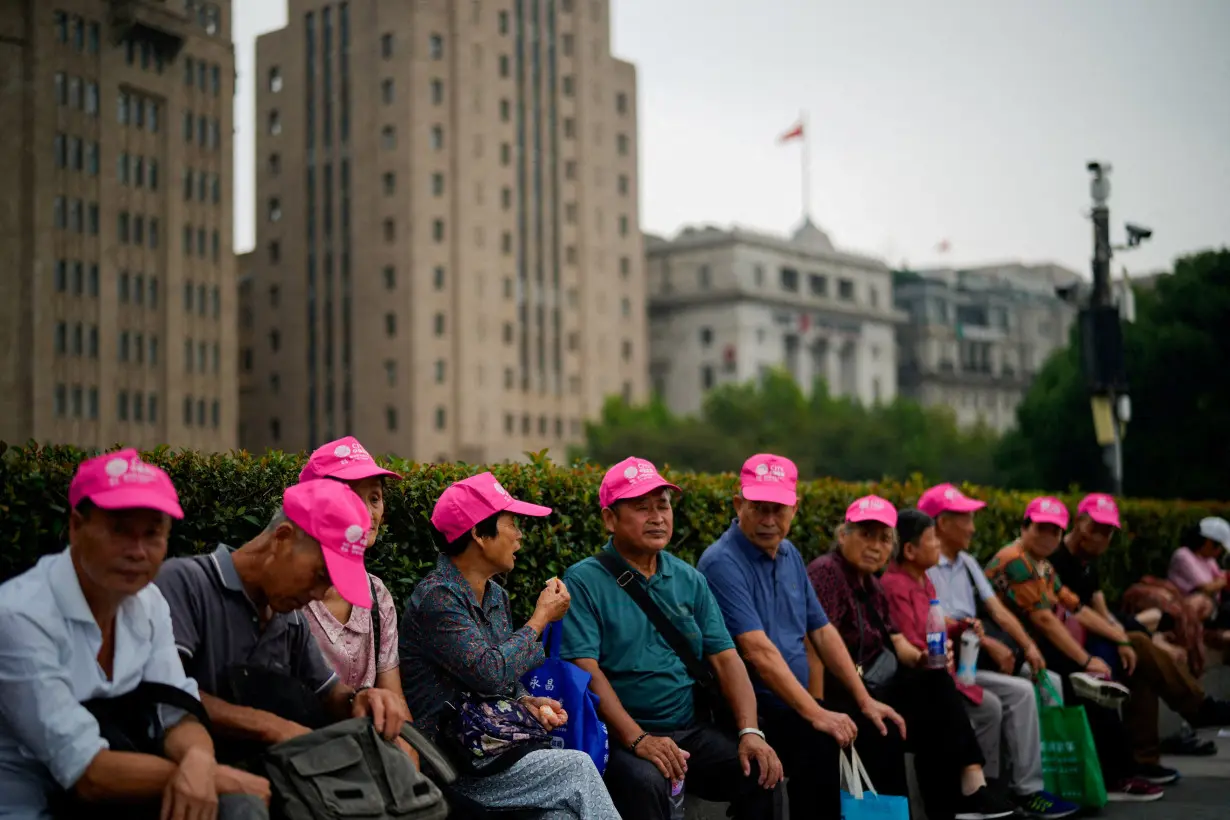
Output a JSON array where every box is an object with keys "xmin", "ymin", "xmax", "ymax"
[{"xmin": 561, "ymin": 457, "xmax": 781, "ymax": 820}]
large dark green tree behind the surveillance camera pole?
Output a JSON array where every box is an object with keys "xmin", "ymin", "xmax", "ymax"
[{"xmin": 996, "ymin": 248, "xmax": 1230, "ymax": 499}]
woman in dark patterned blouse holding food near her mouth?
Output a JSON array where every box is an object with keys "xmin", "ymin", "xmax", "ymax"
[{"xmin": 401, "ymin": 472, "xmax": 619, "ymax": 820}]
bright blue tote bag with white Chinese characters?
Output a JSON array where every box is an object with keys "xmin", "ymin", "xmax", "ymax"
[{"xmin": 522, "ymin": 623, "xmax": 610, "ymax": 775}]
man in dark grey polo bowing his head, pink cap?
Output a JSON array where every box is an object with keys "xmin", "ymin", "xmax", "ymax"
[{"xmin": 155, "ymin": 479, "xmax": 410, "ymax": 761}]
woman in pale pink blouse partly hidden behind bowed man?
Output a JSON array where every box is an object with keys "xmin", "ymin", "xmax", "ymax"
[{"xmin": 299, "ymin": 436, "xmax": 402, "ymax": 697}]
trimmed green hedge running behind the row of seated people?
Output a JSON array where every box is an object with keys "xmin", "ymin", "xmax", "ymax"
[{"xmin": 0, "ymin": 443, "xmax": 1230, "ymax": 616}]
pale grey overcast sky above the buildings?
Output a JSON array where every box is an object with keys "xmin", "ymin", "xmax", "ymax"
[{"xmin": 234, "ymin": 0, "xmax": 1230, "ymax": 273}]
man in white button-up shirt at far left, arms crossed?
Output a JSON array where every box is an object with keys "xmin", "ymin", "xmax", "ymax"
[{"xmin": 0, "ymin": 450, "xmax": 269, "ymax": 820}]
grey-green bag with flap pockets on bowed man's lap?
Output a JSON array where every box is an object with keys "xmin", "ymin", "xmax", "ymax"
[{"xmin": 264, "ymin": 718, "xmax": 456, "ymax": 820}]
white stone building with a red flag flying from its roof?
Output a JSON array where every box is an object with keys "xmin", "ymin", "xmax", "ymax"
[{"xmin": 646, "ymin": 221, "xmax": 905, "ymax": 414}]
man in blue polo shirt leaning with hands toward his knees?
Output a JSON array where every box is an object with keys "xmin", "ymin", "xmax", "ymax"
[{"xmin": 696, "ymin": 454, "xmax": 905, "ymax": 818}]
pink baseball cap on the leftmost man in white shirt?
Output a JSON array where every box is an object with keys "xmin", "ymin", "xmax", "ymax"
[{"xmin": 69, "ymin": 447, "xmax": 183, "ymax": 519}]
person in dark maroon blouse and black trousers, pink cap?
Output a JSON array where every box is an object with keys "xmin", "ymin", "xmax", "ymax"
[{"xmin": 807, "ymin": 495, "xmax": 1016, "ymax": 820}]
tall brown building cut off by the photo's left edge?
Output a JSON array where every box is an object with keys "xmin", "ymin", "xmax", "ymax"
[{"xmin": 0, "ymin": 0, "xmax": 239, "ymax": 450}]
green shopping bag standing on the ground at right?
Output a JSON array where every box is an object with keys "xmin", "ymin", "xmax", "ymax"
[{"xmin": 1034, "ymin": 675, "xmax": 1106, "ymax": 809}]
